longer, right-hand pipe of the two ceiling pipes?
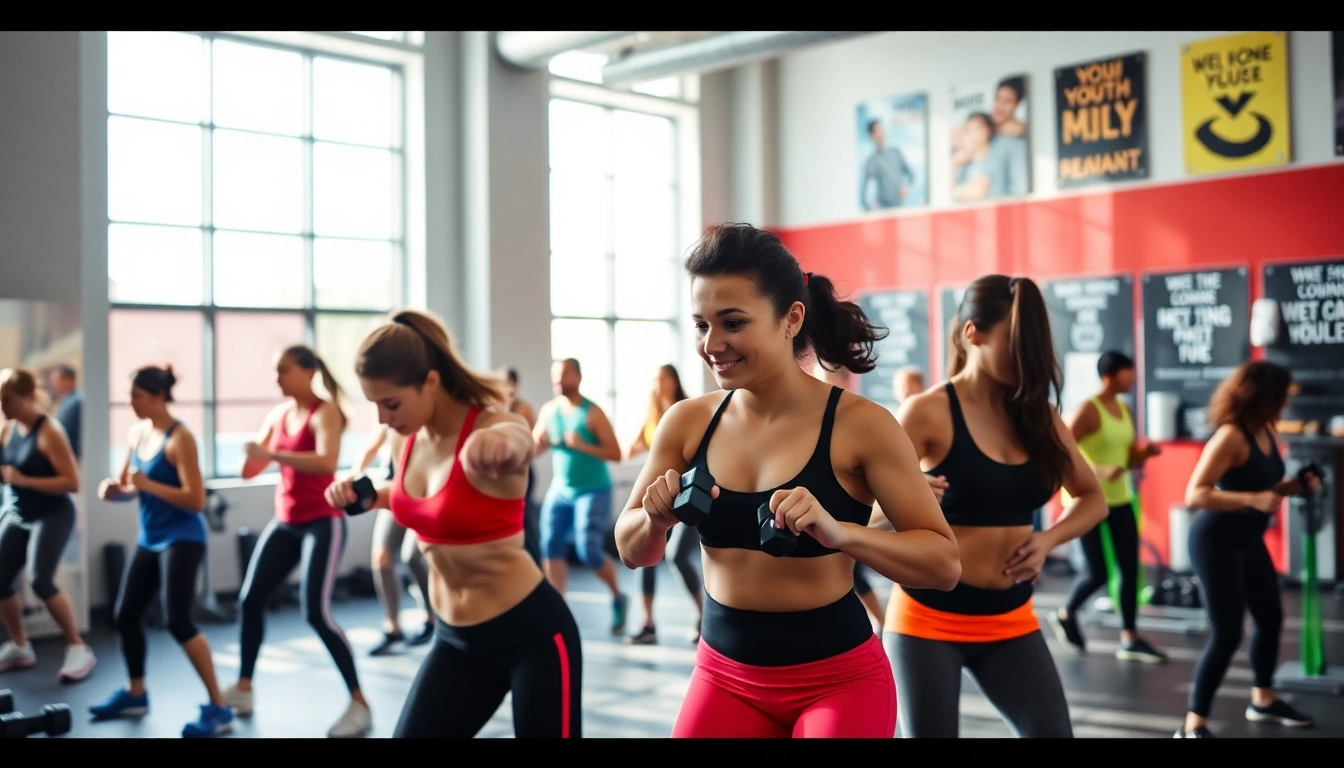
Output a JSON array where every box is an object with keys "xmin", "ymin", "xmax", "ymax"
[{"xmin": 602, "ymin": 32, "xmax": 871, "ymax": 86}]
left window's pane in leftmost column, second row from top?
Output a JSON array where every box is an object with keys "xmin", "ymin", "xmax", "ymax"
[{"xmin": 108, "ymin": 117, "xmax": 203, "ymax": 226}]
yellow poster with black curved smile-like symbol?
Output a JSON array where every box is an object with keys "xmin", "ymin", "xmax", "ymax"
[{"xmin": 1181, "ymin": 32, "xmax": 1290, "ymax": 174}]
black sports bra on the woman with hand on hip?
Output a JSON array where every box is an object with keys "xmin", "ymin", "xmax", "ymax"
[{"xmin": 927, "ymin": 382, "xmax": 1058, "ymax": 527}]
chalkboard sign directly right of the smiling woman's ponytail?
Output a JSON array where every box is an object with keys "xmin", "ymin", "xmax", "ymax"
[{"xmin": 859, "ymin": 291, "xmax": 929, "ymax": 409}]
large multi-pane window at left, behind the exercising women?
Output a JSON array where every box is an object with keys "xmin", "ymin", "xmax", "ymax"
[{"xmin": 108, "ymin": 32, "xmax": 406, "ymax": 477}]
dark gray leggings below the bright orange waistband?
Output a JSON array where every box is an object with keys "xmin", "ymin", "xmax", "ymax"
[{"xmin": 882, "ymin": 629, "xmax": 1074, "ymax": 738}]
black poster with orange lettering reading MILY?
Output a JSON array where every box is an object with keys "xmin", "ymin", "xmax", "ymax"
[{"xmin": 1055, "ymin": 54, "xmax": 1148, "ymax": 188}]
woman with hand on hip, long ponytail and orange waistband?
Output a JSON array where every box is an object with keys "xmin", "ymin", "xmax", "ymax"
[{"xmin": 883, "ymin": 274, "xmax": 1106, "ymax": 738}]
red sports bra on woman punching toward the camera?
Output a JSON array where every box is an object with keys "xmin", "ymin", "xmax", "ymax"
[{"xmin": 390, "ymin": 408, "xmax": 527, "ymax": 545}]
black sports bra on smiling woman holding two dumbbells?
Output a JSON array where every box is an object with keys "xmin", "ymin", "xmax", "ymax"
[{"xmin": 691, "ymin": 387, "xmax": 872, "ymax": 557}]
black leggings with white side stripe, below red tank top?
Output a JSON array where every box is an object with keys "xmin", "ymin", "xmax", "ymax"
[{"xmin": 238, "ymin": 516, "xmax": 359, "ymax": 691}]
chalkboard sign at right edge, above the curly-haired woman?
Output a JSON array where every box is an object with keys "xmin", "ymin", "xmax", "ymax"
[{"xmin": 1265, "ymin": 260, "xmax": 1344, "ymax": 434}]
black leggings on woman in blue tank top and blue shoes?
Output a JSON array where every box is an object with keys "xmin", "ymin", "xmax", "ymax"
[{"xmin": 116, "ymin": 541, "xmax": 206, "ymax": 681}]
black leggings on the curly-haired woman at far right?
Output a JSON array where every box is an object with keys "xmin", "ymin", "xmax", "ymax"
[{"xmin": 1189, "ymin": 511, "xmax": 1284, "ymax": 717}]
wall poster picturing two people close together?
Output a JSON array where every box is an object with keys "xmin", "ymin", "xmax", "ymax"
[{"xmin": 952, "ymin": 75, "xmax": 1031, "ymax": 203}]
